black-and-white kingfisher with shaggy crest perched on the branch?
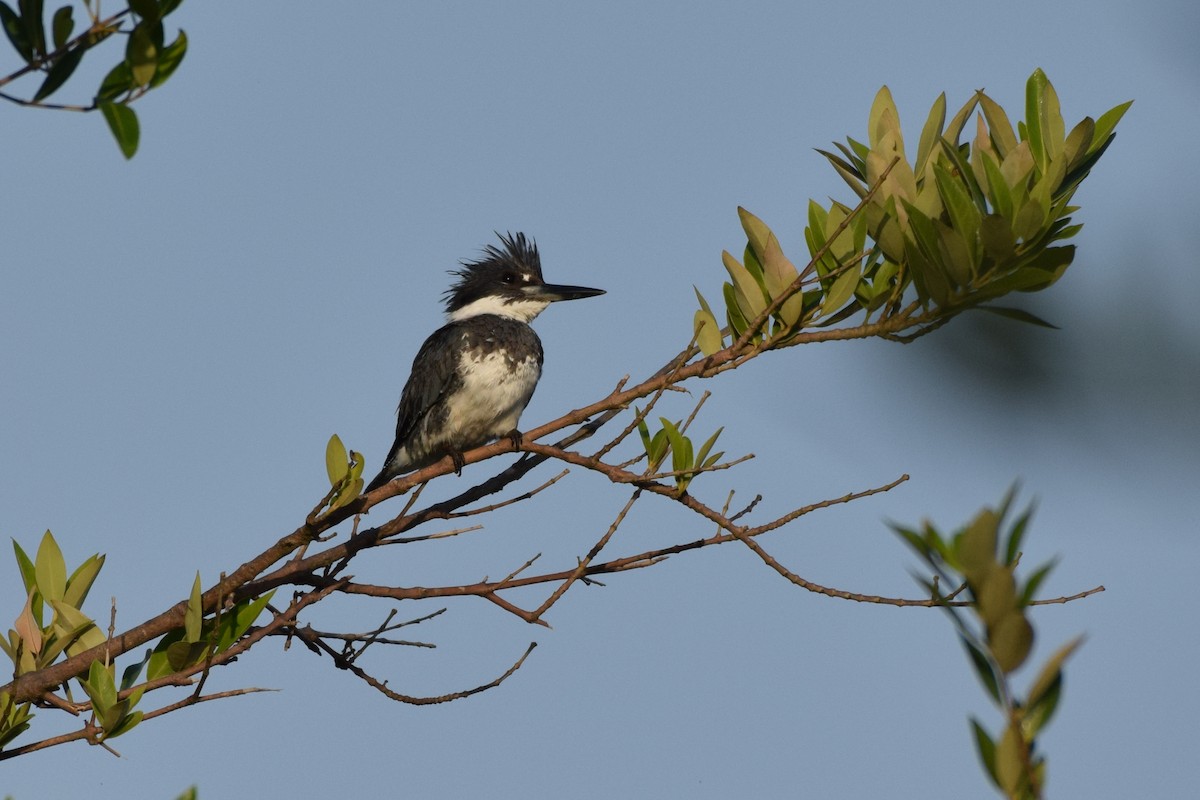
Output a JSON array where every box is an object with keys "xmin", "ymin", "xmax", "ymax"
[{"xmin": 366, "ymin": 233, "xmax": 604, "ymax": 492}]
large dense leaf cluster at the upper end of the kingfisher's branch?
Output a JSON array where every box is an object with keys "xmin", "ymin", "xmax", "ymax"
[{"xmin": 695, "ymin": 70, "xmax": 1130, "ymax": 355}]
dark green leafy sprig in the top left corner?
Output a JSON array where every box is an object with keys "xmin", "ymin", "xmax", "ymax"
[{"xmin": 0, "ymin": 0, "xmax": 187, "ymax": 158}]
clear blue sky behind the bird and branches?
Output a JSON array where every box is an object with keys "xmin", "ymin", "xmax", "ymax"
[{"xmin": 0, "ymin": 0, "xmax": 1200, "ymax": 800}]
